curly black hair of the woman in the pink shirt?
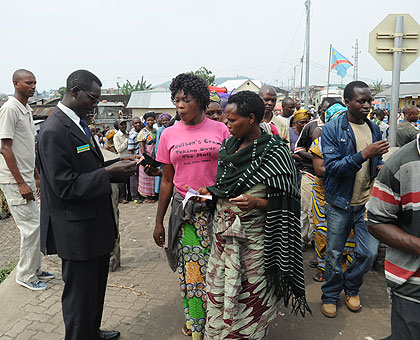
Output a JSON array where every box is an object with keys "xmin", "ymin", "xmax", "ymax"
[{"xmin": 169, "ymin": 73, "xmax": 210, "ymax": 112}]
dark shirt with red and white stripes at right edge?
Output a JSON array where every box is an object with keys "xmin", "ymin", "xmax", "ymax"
[{"xmin": 366, "ymin": 137, "xmax": 420, "ymax": 303}]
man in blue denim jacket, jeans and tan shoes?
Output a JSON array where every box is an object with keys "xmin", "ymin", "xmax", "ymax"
[{"xmin": 321, "ymin": 81, "xmax": 389, "ymax": 317}]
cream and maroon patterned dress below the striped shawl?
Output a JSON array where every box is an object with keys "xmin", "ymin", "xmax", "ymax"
[{"xmin": 205, "ymin": 184, "xmax": 277, "ymax": 340}]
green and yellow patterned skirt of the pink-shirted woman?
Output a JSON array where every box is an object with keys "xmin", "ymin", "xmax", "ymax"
[{"xmin": 178, "ymin": 212, "xmax": 210, "ymax": 340}]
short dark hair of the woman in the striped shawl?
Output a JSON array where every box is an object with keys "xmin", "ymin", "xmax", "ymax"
[{"xmin": 227, "ymin": 91, "xmax": 265, "ymax": 123}]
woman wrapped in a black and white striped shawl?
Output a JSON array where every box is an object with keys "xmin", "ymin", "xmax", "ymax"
[{"xmin": 200, "ymin": 91, "xmax": 309, "ymax": 340}]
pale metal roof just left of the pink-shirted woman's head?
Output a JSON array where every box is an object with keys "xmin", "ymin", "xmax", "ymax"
[{"xmin": 127, "ymin": 90, "xmax": 174, "ymax": 109}]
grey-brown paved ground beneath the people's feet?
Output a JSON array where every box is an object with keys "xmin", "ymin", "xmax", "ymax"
[{"xmin": 0, "ymin": 203, "xmax": 390, "ymax": 340}]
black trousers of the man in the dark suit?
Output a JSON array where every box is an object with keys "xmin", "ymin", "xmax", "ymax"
[{"xmin": 61, "ymin": 255, "xmax": 109, "ymax": 340}]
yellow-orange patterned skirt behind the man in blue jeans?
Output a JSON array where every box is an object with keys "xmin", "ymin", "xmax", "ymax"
[{"xmin": 312, "ymin": 179, "xmax": 356, "ymax": 271}]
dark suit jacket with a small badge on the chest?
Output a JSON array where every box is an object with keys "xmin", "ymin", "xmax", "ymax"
[{"xmin": 38, "ymin": 108, "xmax": 116, "ymax": 261}]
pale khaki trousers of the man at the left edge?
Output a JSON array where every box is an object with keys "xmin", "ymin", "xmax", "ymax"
[{"xmin": 0, "ymin": 182, "xmax": 42, "ymax": 282}]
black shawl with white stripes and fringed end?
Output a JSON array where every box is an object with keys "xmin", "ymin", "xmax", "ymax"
[{"xmin": 208, "ymin": 133, "xmax": 311, "ymax": 316}]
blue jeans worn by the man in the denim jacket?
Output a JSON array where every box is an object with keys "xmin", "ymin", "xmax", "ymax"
[{"xmin": 322, "ymin": 204, "xmax": 379, "ymax": 304}]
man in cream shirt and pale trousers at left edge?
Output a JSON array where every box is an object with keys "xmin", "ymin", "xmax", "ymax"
[{"xmin": 0, "ymin": 69, "xmax": 54, "ymax": 290}]
